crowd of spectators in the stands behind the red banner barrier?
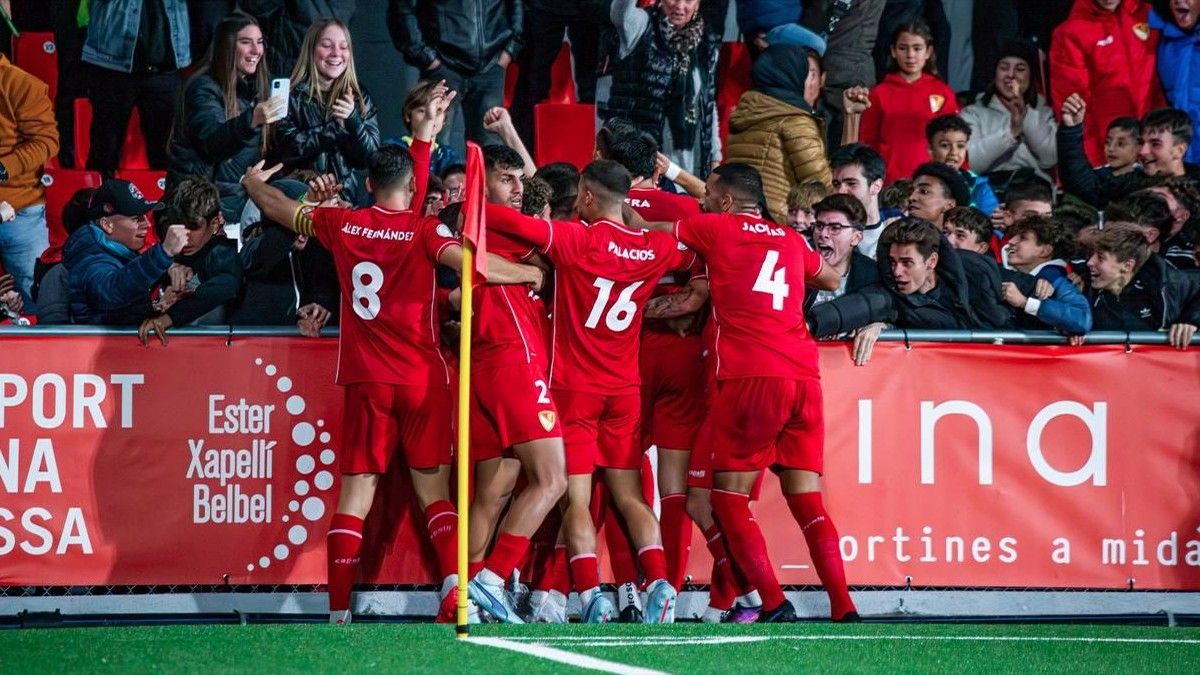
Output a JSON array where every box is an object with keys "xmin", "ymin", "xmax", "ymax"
[{"xmin": 0, "ymin": 0, "xmax": 1200, "ymax": 345}]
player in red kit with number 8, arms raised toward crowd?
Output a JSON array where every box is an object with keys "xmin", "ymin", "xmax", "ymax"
[{"xmin": 242, "ymin": 86, "xmax": 540, "ymax": 623}]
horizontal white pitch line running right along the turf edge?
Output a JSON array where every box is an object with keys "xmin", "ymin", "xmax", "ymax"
[{"xmin": 508, "ymin": 635, "xmax": 1200, "ymax": 647}]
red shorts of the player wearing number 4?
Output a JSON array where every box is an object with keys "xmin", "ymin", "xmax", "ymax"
[{"xmin": 702, "ymin": 377, "xmax": 824, "ymax": 473}]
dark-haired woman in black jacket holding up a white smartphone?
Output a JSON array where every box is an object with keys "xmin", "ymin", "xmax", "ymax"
[{"xmin": 167, "ymin": 12, "xmax": 288, "ymax": 223}]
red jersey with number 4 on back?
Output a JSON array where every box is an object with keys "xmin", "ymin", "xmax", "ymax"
[{"xmin": 674, "ymin": 214, "xmax": 824, "ymax": 380}]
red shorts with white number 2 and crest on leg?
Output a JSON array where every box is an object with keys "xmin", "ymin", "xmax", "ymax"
[{"xmin": 470, "ymin": 363, "xmax": 563, "ymax": 461}]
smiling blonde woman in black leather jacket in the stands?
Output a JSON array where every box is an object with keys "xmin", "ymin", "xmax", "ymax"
[{"xmin": 268, "ymin": 18, "xmax": 379, "ymax": 207}]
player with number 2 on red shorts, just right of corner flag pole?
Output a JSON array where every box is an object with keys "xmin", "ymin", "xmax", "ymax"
[{"xmin": 469, "ymin": 145, "xmax": 566, "ymax": 623}]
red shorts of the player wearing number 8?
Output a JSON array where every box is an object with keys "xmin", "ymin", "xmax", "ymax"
[{"xmin": 341, "ymin": 382, "xmax": 454, "ymax": 473}]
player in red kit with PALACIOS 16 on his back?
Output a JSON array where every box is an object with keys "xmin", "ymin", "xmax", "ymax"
[{"xmin": 487, "ymin": 160, "xmax": 695, "ymax": 623}]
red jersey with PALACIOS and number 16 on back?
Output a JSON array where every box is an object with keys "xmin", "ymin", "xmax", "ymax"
[{"xmin": 487, "ymin": 204, "xmax": 696, "ymax": 394}]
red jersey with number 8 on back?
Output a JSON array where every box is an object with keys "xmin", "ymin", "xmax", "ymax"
[{"xmin": 310, "ymin": 202, "xmax": 460, "ymax": 386}]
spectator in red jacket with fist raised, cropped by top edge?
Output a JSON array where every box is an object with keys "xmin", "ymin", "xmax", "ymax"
[{"xmin": 1050, "ymin": 0, "xmax": 1165, "ymax": 166}]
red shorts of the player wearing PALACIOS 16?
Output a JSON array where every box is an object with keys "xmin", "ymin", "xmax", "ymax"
[{"xmin": 554, "ymin": 390, "xmax": 643, "ymax": 476}]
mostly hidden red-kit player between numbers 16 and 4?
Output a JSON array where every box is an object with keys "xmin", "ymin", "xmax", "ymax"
[{"xmin": 596, "ymin": 119, "xmax": 708, "ymax": 610}]
